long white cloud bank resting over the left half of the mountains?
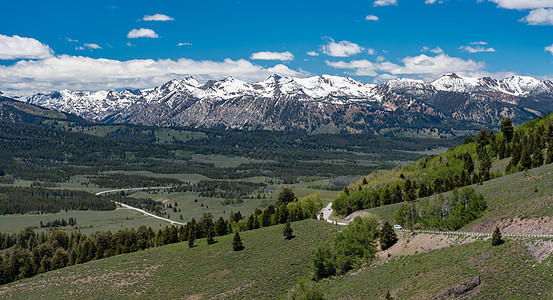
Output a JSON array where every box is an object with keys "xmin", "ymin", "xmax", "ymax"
[{"xmin": 0, "ymin": 55, "xmax": 308, "ymax": 92}]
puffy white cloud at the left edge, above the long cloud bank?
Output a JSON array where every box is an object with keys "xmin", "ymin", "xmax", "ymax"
[{"xmin": 0, "ymin": 34, "xmax": 53, "ymax": 60}]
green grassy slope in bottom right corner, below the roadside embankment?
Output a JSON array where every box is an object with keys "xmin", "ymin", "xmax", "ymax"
[{"xmin": 319, "ymin": 240, "xmax": 553, "ymax": 299}]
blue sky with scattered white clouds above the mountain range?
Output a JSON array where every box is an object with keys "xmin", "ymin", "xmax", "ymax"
[{"xmin": 0, "ymin": 0, "xmax": 553, "ymax": 91}]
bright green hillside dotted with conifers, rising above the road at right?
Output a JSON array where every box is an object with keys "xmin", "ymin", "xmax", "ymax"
[{"xmin": 332, "ymin": 114, "xmax": 553, "ymax": 221}]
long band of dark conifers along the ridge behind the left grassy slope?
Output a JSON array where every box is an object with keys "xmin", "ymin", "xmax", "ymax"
[{"xmin": 0, "ymin": 189, "xmax": 322, "ymax": 284}]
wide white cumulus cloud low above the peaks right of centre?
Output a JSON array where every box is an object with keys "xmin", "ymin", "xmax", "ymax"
[{"xmin": 326, "ymin": 54, "xmax": 485, "ymax": 79}]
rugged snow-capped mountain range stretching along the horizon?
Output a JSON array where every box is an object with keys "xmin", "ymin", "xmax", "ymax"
[{"xmin": 9, "ymin": 73, "xmax": 553, "ymax": 134}]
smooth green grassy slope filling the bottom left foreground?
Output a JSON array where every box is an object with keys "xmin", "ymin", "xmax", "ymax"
[{"xmin": 0, "ymin": 220, "xmax": 337, "ymax": 299}]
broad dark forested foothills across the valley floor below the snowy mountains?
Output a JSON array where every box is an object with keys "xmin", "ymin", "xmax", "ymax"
[{"xmin": 0, "ymin": 116, "xmax": 457, "ymax": 182}]
